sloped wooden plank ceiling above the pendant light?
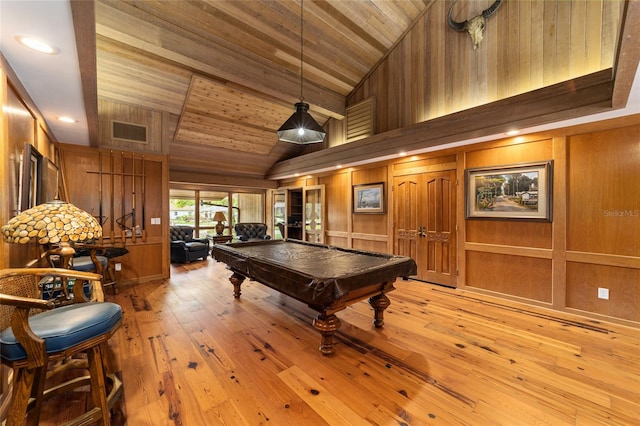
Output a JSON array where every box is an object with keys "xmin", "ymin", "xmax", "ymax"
[{"xmin": 95, "ymin": 0, "xmax": 432, "ymax": 178}]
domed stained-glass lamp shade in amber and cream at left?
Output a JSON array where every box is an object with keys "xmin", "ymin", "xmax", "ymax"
[{"xmin": 2, "ymin": 200, "xmax": 102, "ymax": 244}]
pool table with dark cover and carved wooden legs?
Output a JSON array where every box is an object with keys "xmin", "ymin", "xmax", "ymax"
[{"xmin": 211, "ymin": 240, "xmax": 417, "ymax": 355}]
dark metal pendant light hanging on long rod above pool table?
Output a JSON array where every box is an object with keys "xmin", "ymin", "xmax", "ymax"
[{"xmin": 278, "ymin": 0, "xmax": 326, "ymax": 144}]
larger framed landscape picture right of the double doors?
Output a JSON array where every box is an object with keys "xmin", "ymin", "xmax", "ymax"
[{"xmin": 465, "ymin": 161, "xmax": 553, "ymax": 222}]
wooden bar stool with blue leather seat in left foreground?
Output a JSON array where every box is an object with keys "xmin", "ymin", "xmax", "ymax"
[{"xmin": 0, "ymin": 268, "xmax": 122, "ymax": 426}]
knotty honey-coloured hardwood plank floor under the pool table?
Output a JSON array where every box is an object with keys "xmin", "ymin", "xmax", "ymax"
[{"xmin": 37, "ymin": 259, "xmax": 640, "ymax": 426}]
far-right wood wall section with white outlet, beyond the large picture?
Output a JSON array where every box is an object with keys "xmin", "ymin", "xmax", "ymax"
[{"xmin": 566, "ymin": 126, "xmax": 640, "ymax": 321}]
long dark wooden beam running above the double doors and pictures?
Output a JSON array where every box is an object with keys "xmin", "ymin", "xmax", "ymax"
[{"xmin": 266, "ymin": 69, "xmax": 614, "ymax": 179}]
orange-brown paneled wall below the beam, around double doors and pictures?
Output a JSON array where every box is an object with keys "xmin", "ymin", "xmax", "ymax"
[{"xmin": 278, "ymin": 115, "xmax": 640, "ymax": 326}]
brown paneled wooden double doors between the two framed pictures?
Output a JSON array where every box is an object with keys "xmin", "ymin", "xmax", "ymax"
[{"xmin": 393, "ymin": 170, "xmax": 457, "ymax": 287}]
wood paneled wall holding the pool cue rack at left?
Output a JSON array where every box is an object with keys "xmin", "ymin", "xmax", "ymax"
[{"xmin": 60, "ymin": 144, "xmax": 169, "ymax": 283}]
